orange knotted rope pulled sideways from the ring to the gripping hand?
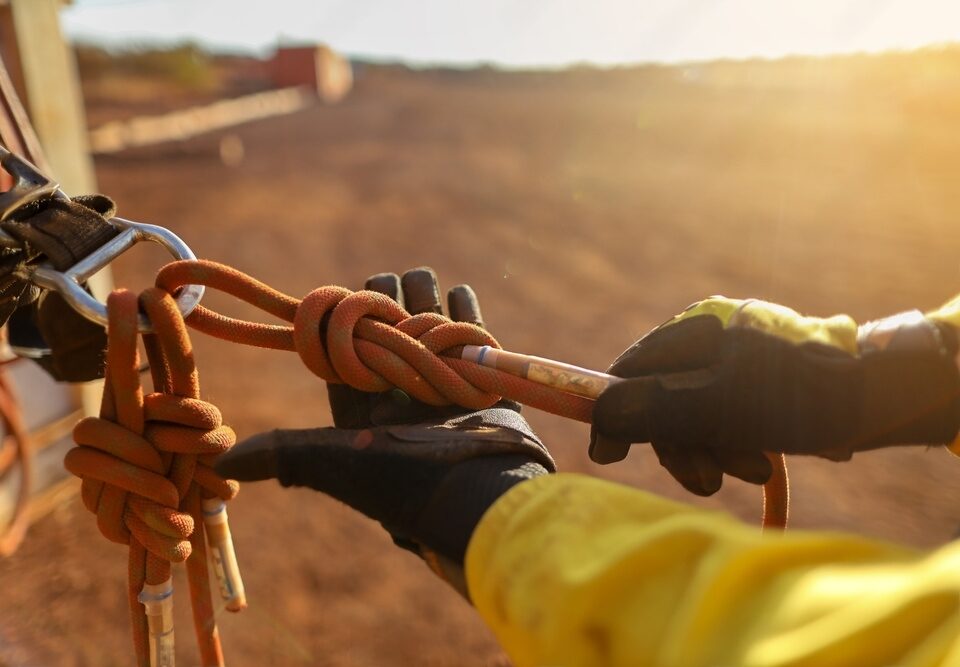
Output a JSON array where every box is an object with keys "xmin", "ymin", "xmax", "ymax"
[{"xmin": 157, "ymin": 260, "xmax": 788, "ymax": 527}]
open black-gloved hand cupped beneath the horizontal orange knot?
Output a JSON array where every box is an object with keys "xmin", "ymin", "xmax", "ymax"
[{"xmin": 216, "ymin": 269, "xmax": 556, "ymax": 585}]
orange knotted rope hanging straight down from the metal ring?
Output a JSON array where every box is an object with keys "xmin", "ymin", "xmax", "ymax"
[{"xmin": 64, "ymin": 288, "xmax": 239, "ymax": 667}]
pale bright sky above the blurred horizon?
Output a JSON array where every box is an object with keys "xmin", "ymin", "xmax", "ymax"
[{"xmin": 63, "ymin": 0, "xmax": 960, "ymax": 66}]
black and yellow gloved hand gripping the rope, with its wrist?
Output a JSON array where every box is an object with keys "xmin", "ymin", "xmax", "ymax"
[{"xmin": 590, "ymin": 297, "xmax": 960, "ymax": 495}]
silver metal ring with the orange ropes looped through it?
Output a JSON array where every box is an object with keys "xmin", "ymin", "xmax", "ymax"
[{"xmin": 16, "ymin": 218, "xmax": 205, "ymax": 333}]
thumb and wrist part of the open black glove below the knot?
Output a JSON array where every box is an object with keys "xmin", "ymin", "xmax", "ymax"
[{"xmin": 216, "ymin": 408, "xmax": 556, "ymax": 565}]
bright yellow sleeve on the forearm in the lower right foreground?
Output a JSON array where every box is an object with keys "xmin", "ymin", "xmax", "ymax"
[{"xmin": 466, "ymin": 474, "xmax": 960, "ymax": 667}]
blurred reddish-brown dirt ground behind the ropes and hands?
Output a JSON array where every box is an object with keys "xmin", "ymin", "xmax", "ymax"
[{"xmin": 0, "ymin": 57, "xmax": 960, "ymax": 666}]
